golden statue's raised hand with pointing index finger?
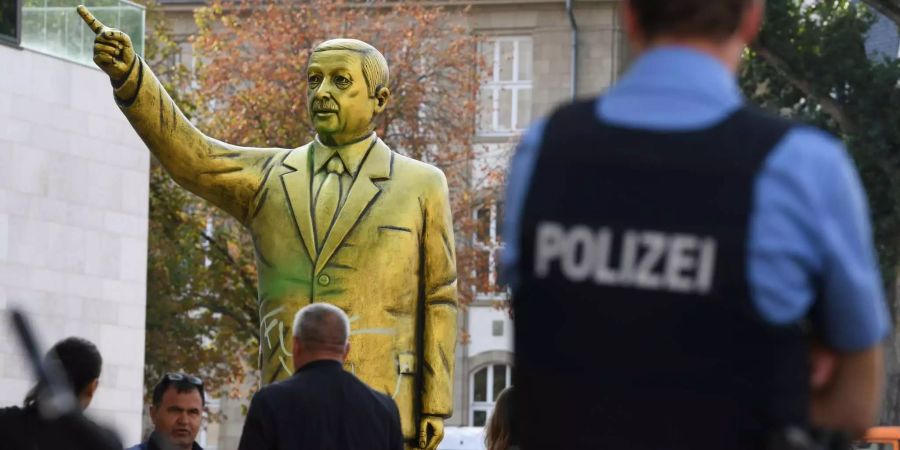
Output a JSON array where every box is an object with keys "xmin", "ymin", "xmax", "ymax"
[{"xmin": 77, "ymin": 5, "xmax": 137, "ymax": 81}]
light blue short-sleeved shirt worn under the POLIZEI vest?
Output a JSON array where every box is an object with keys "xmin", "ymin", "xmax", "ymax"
[{"xmin": 501, "ymin": 46, "xmax": 890, "ymax": 351}]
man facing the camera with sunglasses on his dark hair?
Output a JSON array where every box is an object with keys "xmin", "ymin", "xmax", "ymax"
[{"xmin": 128, "ymin": 373, "xmax": 206, "ymax": 450}]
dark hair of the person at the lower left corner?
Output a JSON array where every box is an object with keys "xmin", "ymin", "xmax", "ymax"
[{"xmin": 25, "ymin": 337, "xmax": 103, "ymax": 407}]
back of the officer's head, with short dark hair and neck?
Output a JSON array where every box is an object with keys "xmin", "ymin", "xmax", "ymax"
[{"xmin": 624, "ymin": 0, "xmax": 764, "ymax": 67}]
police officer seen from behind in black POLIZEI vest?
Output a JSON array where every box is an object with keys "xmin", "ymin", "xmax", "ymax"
[{"xmin": 503, "ymin": 0, "xmax": 889, "ymax": 450}]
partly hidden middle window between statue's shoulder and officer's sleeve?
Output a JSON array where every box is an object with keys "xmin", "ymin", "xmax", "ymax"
[{"xmin": 473, "ymin": 201, "xmax": 504, "ymax": 294}]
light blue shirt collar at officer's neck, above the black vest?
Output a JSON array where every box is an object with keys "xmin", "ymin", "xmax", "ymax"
[{"xmin": 610, "ymin": 45, "xmax": 743, "ymax": 108}]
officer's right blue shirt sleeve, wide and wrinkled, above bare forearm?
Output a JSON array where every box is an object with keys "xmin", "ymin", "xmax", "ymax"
[{"xmin": 748, "ymin": 127, "xmax": 890, "ymax": 351}]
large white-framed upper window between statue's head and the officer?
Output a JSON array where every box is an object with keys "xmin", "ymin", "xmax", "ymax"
[{"xmin": 478, "ymin": 37, "xmax": 532, "ymax": 136}]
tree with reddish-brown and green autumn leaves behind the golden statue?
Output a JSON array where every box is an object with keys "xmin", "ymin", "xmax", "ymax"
[{"xmin": 145, "ymin": 0, "xmax": 499, "ymax": 398}]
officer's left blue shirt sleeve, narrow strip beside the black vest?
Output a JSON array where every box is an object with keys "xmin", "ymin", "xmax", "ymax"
[{"xmin": 500, "ymin": 119, "xmax": 546, "ymax": 288}]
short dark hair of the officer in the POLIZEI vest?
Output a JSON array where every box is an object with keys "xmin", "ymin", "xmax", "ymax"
[{"xmin": 629, "ymin": 0, "xmax": 763, "ymax": 40}]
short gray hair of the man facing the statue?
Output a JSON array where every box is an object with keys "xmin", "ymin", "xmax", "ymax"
[{"xmin": 294, "ymin": 303, "xmax": 350, "ymax": 347}]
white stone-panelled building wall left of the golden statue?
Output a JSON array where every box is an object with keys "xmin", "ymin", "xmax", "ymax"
[{"xmin": 0, "ymin": 45, "xmax": 150, "ymax": 444}]
